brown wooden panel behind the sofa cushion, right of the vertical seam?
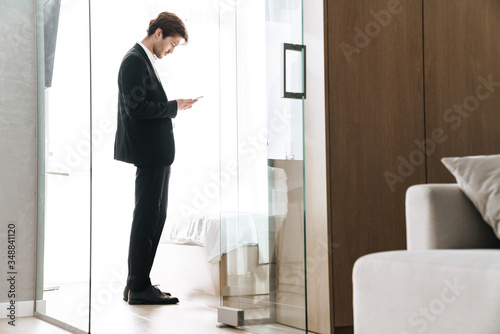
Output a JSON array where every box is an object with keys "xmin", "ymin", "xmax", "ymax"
[{"xmin": 424, "ymin": 0, "xmax": 500, "ymax": 183}]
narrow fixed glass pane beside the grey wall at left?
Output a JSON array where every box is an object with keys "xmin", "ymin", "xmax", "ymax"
[{"xmin": 36, "ymin": 0, "xmax": 92, "ymax": 333}]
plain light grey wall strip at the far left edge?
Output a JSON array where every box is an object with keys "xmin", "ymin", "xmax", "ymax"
[{"xmin": 0, "ymin": 0, "xmax": 37, "ymax": 306}]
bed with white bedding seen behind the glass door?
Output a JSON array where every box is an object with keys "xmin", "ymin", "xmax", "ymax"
[{"xmin": 152, "ymin": 169, "xmax": 288, "ymax": 307}]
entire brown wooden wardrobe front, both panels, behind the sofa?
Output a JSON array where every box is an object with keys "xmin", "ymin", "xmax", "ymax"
[{"xmin": 324, "ymin": 0, "xmax": 500, "ymax": 333}]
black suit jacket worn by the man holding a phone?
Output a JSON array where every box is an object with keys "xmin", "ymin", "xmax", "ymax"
[{"xmin": 115, "ymin": 44, "xmax": 177, "ymax": 166}]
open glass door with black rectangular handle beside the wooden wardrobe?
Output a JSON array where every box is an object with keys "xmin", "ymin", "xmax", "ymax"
[{"xmin": 221, "ymin": 0, "xmax": 307, "ymax": 333}]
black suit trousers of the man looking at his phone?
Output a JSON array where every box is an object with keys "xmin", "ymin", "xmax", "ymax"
[{"xmin": 127, "ymin": 166, "xmax": 170, "ymax": 291}]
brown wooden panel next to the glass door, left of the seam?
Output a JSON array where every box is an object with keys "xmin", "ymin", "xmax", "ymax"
[{"xmin": 326, "ymin": 0, "xmax": 425, "ymax": 327}]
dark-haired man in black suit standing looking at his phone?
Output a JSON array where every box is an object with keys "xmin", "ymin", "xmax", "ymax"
[{"xmin": 115, "ymin": 12, "xmax": 196, "ymax": 304}]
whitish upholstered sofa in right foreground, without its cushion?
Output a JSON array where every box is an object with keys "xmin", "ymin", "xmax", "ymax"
[{"xmin": 353, "ymin": 184, "xmax": 500, "ymax": 334}]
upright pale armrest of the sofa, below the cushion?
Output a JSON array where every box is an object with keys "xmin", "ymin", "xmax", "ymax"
[{"xmin": 406, "ymin": 184, "xmax": 500, "ymax": 250}]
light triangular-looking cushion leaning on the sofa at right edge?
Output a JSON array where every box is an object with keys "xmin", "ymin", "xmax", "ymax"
[{"xmin": 441, "ymin": 155, "xmax": 500, "ymax": 238}]
